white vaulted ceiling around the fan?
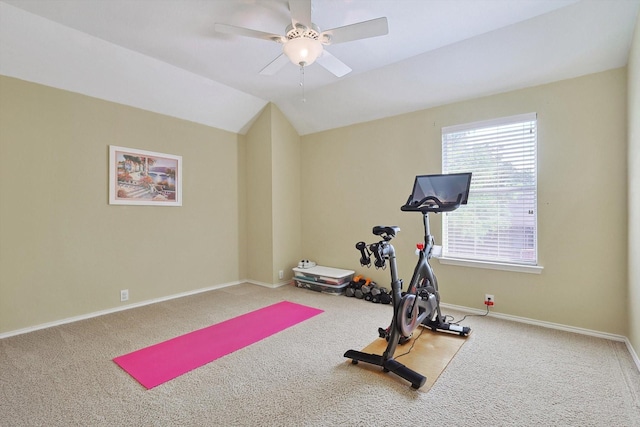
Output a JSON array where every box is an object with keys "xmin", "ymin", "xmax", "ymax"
[{"xmin": 0, "ymin": 0, "xmax": 640, "ymax": 135}]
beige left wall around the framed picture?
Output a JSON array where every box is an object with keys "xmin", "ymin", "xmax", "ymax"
[{"xmin": 0, "ymin": 77, "xmax": 241, "ymax": 333}]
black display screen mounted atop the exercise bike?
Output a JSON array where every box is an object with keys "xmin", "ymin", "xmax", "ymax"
[{"xmin": 410, "ymin": 172, "xmax": 471, "ymax": 205}]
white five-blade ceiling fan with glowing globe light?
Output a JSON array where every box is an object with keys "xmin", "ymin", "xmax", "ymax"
[{"xmin": 214, "ymin": 0, "xmax": 389, "ymax": 77}]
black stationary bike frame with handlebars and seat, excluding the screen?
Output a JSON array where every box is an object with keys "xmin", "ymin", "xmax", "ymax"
[{"xmin": 344, "ymin": 197, "xmax": 471, "ymax": 389}]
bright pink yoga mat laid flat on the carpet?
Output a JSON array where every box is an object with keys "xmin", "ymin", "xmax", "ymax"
[{"xmin": 113, "ymin": 301, "xmax": 323, "ymax": 389}]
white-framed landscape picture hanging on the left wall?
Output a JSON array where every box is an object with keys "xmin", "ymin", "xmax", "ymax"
[{"xmin": 109, "ymin": 145, "xmax": 182, "ymax": 206}]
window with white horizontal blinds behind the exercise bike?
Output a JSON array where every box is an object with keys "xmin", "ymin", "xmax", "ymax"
[{"xmin": 442, "ymin": 113, "xmax": 538, "ymax": 266}]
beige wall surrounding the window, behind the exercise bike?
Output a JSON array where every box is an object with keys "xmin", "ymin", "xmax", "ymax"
[{"xmin": 301, "ymin": 69, "xmax": 628, "ymax": 336}]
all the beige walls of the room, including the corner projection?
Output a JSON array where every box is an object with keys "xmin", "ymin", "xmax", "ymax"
[{"xmin": 0, "ymin": 59, "xmax": 640, "ymax": 349}]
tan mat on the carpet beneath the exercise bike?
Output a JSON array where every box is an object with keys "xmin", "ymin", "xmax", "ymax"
[{"xmin": 349, "ymin": 327, "xmax": 467, "ymax": 393}]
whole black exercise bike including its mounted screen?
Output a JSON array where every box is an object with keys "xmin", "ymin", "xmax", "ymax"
[{"xmin": 344, "ymin": 173, "xmax": 471, "ymax": 389}]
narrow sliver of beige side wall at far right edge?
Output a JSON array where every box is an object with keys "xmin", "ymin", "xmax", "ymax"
[{"xmin": 628, "ymin": 11, "xmax": 640, "ymax": 355}]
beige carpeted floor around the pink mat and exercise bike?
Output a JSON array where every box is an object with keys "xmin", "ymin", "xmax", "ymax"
[{"xmin": 0, "ymin": 284, "xmax": 640, "ymax": 427}]
